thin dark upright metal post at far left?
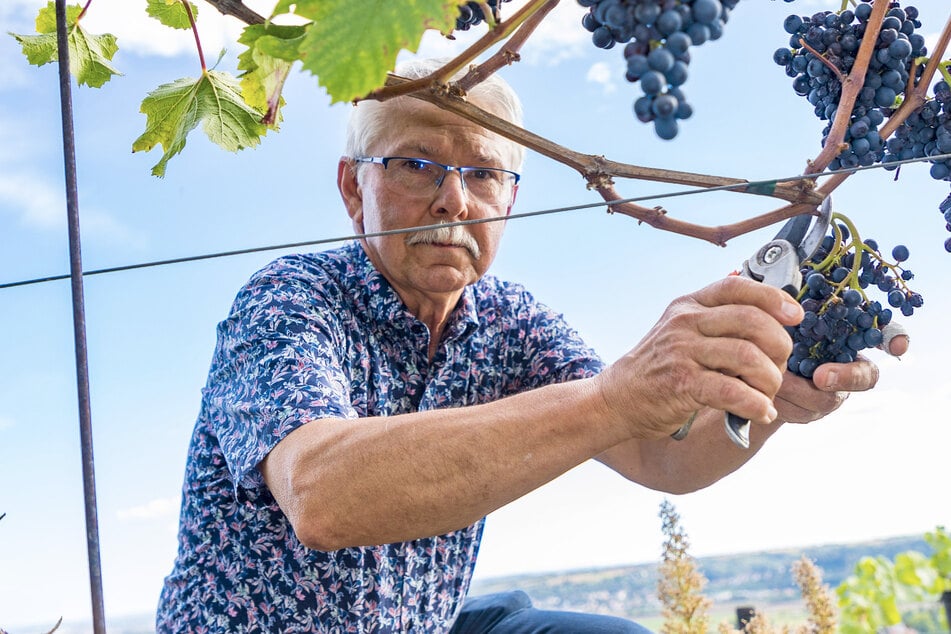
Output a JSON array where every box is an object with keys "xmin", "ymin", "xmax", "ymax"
[{"xmin": 56, "ymin": 0, "xmax": 106, "ymax": 634}]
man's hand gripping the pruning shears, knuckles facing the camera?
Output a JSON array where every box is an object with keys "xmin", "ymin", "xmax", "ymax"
[{"xmin": 598, "ymin": 276, "xmax": 803, "ymax": 438}]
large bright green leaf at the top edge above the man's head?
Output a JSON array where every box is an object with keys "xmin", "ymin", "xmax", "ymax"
[{"xmin": 296, "ymin": 0, "xmax": 460, "ymax": 102}]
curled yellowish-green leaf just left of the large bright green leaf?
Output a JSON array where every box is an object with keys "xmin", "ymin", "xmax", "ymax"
[{"xmin": 238, "ymin": 23, "xmax": 306, "ymax": 129}]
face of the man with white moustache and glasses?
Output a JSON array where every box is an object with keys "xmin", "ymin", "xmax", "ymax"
[{"xmin": 338, "ymin": 98, "xmax": 515, "ymax": 308}]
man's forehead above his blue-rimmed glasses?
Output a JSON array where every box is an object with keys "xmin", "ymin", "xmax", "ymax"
[{"xmin": 372, "ymin": 97, "xmax": 511, "ymax": 163}]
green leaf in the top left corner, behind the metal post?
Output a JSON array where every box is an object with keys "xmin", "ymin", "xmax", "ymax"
[{"xmin": 10, "ymin": 1, "xmax": 122, "ymax": 88}]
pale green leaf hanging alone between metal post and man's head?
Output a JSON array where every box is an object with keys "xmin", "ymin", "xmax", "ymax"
[{"xmin": 132, "ymin": 70, "xmax": 267, "ymax": 177}]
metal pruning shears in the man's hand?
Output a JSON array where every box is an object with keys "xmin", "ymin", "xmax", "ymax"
[{"xmin": 671, "ymin": 195, "xmax": 832, "ymax": 449}]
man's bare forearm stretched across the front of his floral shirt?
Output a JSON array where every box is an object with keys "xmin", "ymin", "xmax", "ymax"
[{"xmin": 262, "ymin": 380, "xmax": 625, "ymax": 549}]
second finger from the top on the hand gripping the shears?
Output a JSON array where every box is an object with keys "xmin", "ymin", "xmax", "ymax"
[{"xmin": 697, "ymin": 305, "xmax": 792, "ymax": 367}]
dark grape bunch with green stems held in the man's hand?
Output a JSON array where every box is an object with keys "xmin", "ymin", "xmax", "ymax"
[{"xmin": 786, "ymin": 214, "xmax": 924, "ymax": 378}]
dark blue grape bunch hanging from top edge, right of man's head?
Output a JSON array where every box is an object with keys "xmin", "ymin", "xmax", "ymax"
[{"xmin": 578, "ymin": 0, "xmax": 739, "ymax": 140}]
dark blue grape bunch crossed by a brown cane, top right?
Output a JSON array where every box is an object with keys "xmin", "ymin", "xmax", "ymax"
[{"xmin": 773, "ymin": 0, "xmax": 927, "ymax": 170}]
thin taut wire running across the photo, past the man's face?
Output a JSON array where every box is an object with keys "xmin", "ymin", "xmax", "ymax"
[{"xmin": 0, "ymin": 153, "xmax": 951, "ymax": 290}]
